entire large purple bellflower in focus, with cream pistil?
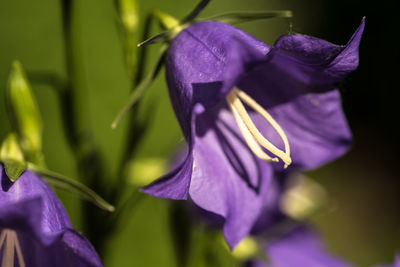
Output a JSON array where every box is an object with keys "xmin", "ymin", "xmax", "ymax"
[{"xmin": 143, "ymin": 20, "xmax": 364, "ymax": 248}]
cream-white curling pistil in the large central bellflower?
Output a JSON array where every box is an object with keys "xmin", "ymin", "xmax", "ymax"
[{"xmin": 226, "ymin": 87, "xmax": 292, "ymax": 168}]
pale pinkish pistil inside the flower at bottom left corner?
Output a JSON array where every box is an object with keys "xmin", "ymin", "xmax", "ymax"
[{"xmin": 0, "ymin": 229, "xmax": 25, "ymax": 267}]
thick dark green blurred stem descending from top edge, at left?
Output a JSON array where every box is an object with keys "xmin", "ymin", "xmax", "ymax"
[{"xmin": 60, "ymin": 0, "xmax": 107, "ymax": 254}]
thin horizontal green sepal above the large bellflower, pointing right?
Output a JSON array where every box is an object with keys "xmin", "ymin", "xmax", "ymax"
[{"xmin": 205, "ymin": 10, "xmax": 293, "ymax": 24}]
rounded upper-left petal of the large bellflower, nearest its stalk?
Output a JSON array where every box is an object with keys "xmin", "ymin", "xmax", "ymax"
[{"xmin": 165, "ymin": 21, "xmax": 269, "ymax": 134}]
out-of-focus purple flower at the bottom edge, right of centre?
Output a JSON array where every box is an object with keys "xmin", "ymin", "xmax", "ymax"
[{"xmin": 248, "ymin": 226, "xmax": 352, "ymax": 267}]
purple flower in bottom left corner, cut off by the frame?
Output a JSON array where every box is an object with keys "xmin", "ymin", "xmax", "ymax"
[{"xmin": 0, "ymin": 165, "xmax": 102, "ymax": 267}]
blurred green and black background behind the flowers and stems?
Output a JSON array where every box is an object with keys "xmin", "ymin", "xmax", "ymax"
[{"xmin": 0, "ymin": 0, "xmax": 400, "ymax": 267}]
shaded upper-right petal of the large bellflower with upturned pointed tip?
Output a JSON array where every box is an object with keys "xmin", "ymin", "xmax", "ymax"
[{"xmin": 238, "ymin": 20, "xmax": 364, "ymax": 110}]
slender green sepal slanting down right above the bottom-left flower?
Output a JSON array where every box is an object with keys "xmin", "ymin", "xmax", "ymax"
[{"xmin": 28, "ymin": 163, "xmax": 115, "ymax": 212}]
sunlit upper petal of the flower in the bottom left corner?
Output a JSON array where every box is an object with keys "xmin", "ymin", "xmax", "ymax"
[{"xmin": 0, "ymin": 169, "xmax": 71, "ymax": 245}]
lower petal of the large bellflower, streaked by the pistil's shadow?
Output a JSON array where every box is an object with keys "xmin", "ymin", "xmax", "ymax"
[{"xmin": 190, "ymin": 104, "xmax": 272, "ymax": 248}]
